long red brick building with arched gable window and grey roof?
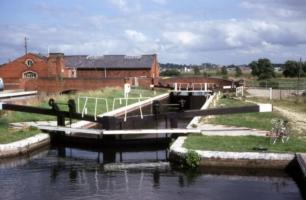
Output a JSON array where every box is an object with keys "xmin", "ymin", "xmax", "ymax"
[{"xmin": 0, "ymin": 53, "xmax": 159, "ymax": 90}]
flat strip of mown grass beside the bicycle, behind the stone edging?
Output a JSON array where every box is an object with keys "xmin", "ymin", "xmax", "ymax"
[{"xmin": 184, "ymin": 135, "xmax": 306, "ymax": 153}]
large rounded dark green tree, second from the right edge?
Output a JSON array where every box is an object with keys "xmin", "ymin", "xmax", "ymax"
[{"xmin": 249, "ymin": 58, "xmax": 275, "ymax": 80}]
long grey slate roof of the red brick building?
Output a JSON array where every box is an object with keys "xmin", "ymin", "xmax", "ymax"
[{"xmin": 64, "ymin": 54, "xmax": 155, "ymax": 69}]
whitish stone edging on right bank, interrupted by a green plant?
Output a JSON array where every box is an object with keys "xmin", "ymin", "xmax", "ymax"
[{"xmin": 170, "ymin": 137, "xmax": 295, "ymax": 167}]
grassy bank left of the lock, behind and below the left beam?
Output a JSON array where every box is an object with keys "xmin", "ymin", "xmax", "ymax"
[{"xmin": 0, "ymin": 88, "xmax": 165, "ymax": 144}]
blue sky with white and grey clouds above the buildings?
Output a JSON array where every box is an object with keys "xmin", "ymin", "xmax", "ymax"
[{"xmin": 0, "ymin": 0, "xmax": 306, "ymax": 65}]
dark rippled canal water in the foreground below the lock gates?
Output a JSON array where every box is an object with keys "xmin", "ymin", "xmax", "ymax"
[{"xmin": 0, "ymin": 146, "xmax": 303, "ymax": 200}]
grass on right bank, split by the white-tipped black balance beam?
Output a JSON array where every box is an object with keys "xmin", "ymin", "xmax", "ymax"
[{"xmin": 202, "ymin": 98, "xmax": 284, "ymax": 130}]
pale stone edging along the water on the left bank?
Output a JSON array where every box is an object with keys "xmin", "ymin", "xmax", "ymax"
[{"xmin": 0, "ymin": 133, "xmax": 50, "ymax": 158}]
